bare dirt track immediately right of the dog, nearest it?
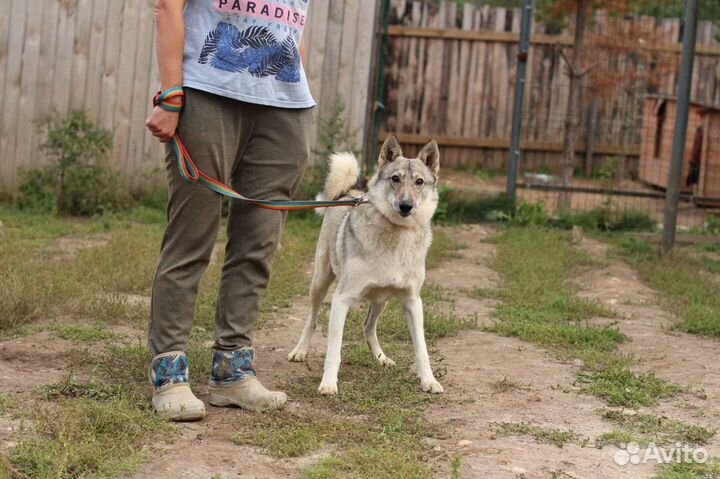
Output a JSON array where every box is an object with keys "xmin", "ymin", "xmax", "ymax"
[{"xmin": 428, "ymin": 226, "xmax": 660, "ymax": 478}]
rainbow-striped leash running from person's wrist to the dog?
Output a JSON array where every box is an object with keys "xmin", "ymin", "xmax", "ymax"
[{"xmin": 153, "ymin": 87, "xmax": 368, "ymax": 211}]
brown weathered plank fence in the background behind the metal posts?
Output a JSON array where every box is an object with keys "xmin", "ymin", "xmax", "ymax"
[{"xmin": 384, "ymin": 1, "xmax": 720, "ymax": 171}]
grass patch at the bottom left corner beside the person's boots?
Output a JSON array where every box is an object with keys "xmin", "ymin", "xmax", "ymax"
[{"xmin": 9, "ymin": 344, "xmax": 178, "ymax": 478}]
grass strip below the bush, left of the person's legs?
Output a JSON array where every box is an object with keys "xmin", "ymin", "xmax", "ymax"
[{"xmin": 0, "ymin": 208, "xmax": 162, "ymax": 333}]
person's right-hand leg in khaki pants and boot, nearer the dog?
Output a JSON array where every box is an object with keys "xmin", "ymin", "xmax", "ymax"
[{"xmin": 205, "ymin": 105, "xmax": 311, "ymax": 409}]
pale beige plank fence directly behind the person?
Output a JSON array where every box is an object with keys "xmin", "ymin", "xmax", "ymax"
[{"xmin": 0, "ymin": 0, "xmax": 376, "ymax": 194}]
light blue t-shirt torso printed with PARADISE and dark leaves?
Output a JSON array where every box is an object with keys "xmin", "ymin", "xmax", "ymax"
[{"xmin": 183, "ymin": 0, "xmax": 315, "ymax": 108}]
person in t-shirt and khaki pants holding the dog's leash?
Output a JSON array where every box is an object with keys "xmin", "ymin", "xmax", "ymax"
[{"xmin": 146, "ymin": 0, "xmax": 315, "ymax": 420}]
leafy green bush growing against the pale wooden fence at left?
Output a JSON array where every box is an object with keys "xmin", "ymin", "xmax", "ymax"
[{"xmin": 17, "ymin": 111, "xmax": 129, "ymax": 216}]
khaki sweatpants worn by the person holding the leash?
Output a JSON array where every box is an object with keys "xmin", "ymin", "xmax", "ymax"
[{"xmin": 148, "ymin": 88, "xmax": 311, "ymax": 355}]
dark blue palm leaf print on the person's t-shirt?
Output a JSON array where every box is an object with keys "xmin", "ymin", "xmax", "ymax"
[{"xmin": 198, "ymin": 22, "xmax": 300, "ymax": 83}]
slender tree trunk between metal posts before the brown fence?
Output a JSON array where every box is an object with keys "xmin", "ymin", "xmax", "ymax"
[{"xmin": 558, "ymin": 0, "xmax": 590, "ymax": 211}]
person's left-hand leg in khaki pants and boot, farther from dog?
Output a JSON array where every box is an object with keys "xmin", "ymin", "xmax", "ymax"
[{"xmin": 148, "ymin": 89, "xmax": 245, "ymax": 419}]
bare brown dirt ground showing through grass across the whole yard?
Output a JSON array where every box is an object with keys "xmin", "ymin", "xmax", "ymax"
[{"xmin": 0, "ymin": 225, "xmax": 720, "ymax": 479}]
